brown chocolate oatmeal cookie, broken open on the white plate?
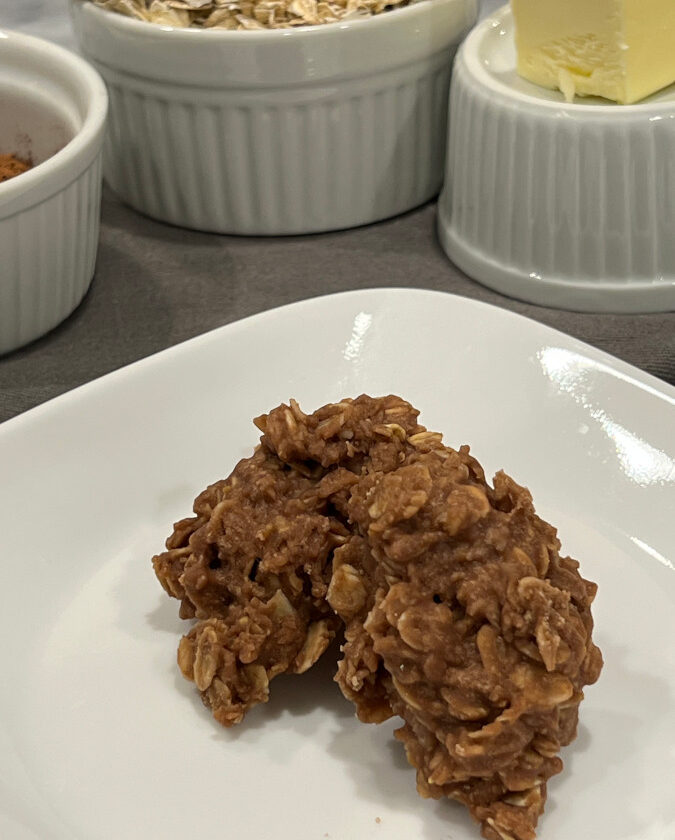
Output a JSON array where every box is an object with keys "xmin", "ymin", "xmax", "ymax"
[{"xmin": 153, "ymin": 396, "xmax": 602, "ymax": 840}]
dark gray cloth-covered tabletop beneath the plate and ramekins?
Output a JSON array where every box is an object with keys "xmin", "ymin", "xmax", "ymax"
[{"xmin": 0, "ymin": 0, "xmax": 675, "ymax": 421}]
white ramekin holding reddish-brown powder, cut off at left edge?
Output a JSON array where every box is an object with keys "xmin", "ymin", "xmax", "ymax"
[{"xmin": 0, "ymin": 29, "xmax": 108, "ymax": 353}]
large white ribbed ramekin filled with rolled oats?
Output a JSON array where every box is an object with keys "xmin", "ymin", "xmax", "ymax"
[{"xmin": 71, "ymin": 0, "xmax": 477, "ymax": 234}]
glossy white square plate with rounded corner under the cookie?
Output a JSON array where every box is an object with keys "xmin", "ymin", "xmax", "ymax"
[{"xmin": 0, "ymin": 289, "xmax": 675, "ymax": 840}]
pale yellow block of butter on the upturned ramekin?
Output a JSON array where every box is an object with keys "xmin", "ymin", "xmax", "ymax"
[{"xmin": 511, "ymin": 0, "xmax": 675, "ymax": 104}]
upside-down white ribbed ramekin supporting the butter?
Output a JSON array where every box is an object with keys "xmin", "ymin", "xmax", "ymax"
[{"xmin": 438, "ymin": 7, "xmax": 675, "ymax": 312}]
